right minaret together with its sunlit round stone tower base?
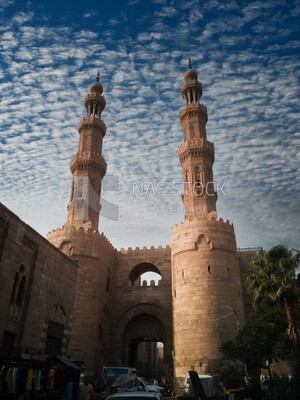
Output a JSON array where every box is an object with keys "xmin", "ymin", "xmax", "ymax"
[{"xmin": 171, "ymin": 61, "xmax": 244, "ymax": 389}]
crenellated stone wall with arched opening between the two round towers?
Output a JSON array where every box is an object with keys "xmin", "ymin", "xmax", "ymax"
[{"xmin": 108, "ymin": 246, "xmax": 173, "ymax": 371}]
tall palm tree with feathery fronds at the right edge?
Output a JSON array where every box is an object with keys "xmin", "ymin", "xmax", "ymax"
[{"xmin": 247, "ymin": 244, "xmax": 300, "ymax": 399}]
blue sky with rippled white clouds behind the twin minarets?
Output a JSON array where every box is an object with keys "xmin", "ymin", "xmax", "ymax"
[{"xmin": 0, "ymin": 0, "xmax": 300, "ymax": 249}]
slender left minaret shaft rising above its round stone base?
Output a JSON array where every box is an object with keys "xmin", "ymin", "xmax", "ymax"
[{"xmin": 66, "ymin": 73, "xmax": 106, "ymax": 230}]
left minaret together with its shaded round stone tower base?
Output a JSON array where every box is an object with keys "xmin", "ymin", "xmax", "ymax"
[{"xmin": 47, "ymin": 74, "xmax": 116, "ymax": 373}]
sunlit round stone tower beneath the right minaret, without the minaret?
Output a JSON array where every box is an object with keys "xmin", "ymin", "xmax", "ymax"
[{"xmin": 171, "ymin": 217, "xmax": 244, "ymax": 386}]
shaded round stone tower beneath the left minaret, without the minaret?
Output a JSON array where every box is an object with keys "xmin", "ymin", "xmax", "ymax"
[{"xmin": 47, "ymin": 227, "xmax": 117, "ymax": 375}]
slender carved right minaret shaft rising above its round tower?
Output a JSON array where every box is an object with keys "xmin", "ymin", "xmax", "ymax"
[{"xmin": 179, "ymin": 61, "xmax": 217, "ymax": 219}]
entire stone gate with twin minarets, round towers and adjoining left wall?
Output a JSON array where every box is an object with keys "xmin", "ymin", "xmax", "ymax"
[{"xmin": 0, "ymin": 62, "xmax": 255, "ymax": 394}]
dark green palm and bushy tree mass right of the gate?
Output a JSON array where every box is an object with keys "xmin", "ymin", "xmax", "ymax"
[{"xmin": 220, "ymin": 245, "xmax": 300, "ymax": 398}]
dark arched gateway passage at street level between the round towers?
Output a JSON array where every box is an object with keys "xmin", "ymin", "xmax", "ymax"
[{"xmin": 123, "ymin": 313, "xmax": 169, "ymax": 378}]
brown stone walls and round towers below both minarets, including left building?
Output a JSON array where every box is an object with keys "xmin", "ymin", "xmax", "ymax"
[{"xmin": 0, "ymin": 205, "xmax": 256, "ymax": 376}]
